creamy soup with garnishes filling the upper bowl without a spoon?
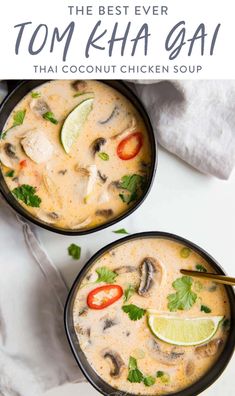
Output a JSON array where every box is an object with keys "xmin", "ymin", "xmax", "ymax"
[{"xmin": 0, "ymin": 81, "xmax": 151, "ymax": 229}]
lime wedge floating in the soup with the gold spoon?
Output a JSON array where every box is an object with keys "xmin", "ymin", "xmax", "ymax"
[{"xmin": 148, "ymin": 311, "xmax": 223, "ymax": 346}]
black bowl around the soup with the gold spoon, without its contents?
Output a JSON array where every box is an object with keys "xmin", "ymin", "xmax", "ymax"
[{"xmin": 64, "ymin": 231, "xmax": 235, "ymax": 396}]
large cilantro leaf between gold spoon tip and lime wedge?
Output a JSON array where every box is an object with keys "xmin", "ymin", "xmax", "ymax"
[{"xmin": 167, "ymin": 276, "xmax": 197, "ymax": 311}]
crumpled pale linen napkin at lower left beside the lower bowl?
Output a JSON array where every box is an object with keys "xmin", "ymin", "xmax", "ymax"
[{"xmin": 0, "ymin": 200, "xmax": 84, "ymax": 396}]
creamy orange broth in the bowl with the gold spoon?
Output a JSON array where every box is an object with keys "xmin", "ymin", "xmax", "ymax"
[{"xmin": 73, "ymin": 238, "xmax": 230, "ymax": 395}]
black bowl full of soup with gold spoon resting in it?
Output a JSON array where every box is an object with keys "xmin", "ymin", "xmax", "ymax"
[{"xmin": 66, "ymin": 233, "xmax": 235, "ymax": 396}]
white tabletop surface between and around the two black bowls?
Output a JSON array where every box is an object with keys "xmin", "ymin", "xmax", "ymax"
[{"xmin": 42, "ymin": 146, "xmax": 235, "ymax": 396}]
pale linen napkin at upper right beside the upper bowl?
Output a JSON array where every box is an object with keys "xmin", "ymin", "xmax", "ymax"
[{"xmin": 131, "ymin": 80, "xmax": 235, "ymax": 179}]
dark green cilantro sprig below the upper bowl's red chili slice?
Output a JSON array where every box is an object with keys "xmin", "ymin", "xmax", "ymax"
[{"xmin": 119, "ymin": 174, "xmax": 146, "ymax": 204}]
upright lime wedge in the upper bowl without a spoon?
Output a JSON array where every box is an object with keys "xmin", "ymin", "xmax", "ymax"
[{"xmin": 61, "ymin": 98, "xmax": 94, "ymax": 154}]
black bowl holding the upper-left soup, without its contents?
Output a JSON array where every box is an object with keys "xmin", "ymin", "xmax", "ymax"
[{"xmin": 0, "ymin": 80, "xmax": 157, "ymax": 235}]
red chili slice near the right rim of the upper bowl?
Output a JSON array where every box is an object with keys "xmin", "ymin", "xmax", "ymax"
[{"xmin": 117, "ymin": 132, "xmax": 144, "ymax": 160}]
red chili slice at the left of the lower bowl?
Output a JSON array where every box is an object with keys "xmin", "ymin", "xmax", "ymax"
[{"xmin": 87, "ymin": 285, "xmax": 123, "ymax": 309}]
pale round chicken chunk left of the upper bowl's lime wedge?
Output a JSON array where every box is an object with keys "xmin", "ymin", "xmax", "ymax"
[{"xmin": 21, "ymin": 130, "xmax": 54, "ymax": 164}]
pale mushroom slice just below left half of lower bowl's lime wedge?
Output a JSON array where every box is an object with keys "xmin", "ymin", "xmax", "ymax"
[{"xmin": 147, "ymin": 338, "xmax": 184, "ymax": 366}]
